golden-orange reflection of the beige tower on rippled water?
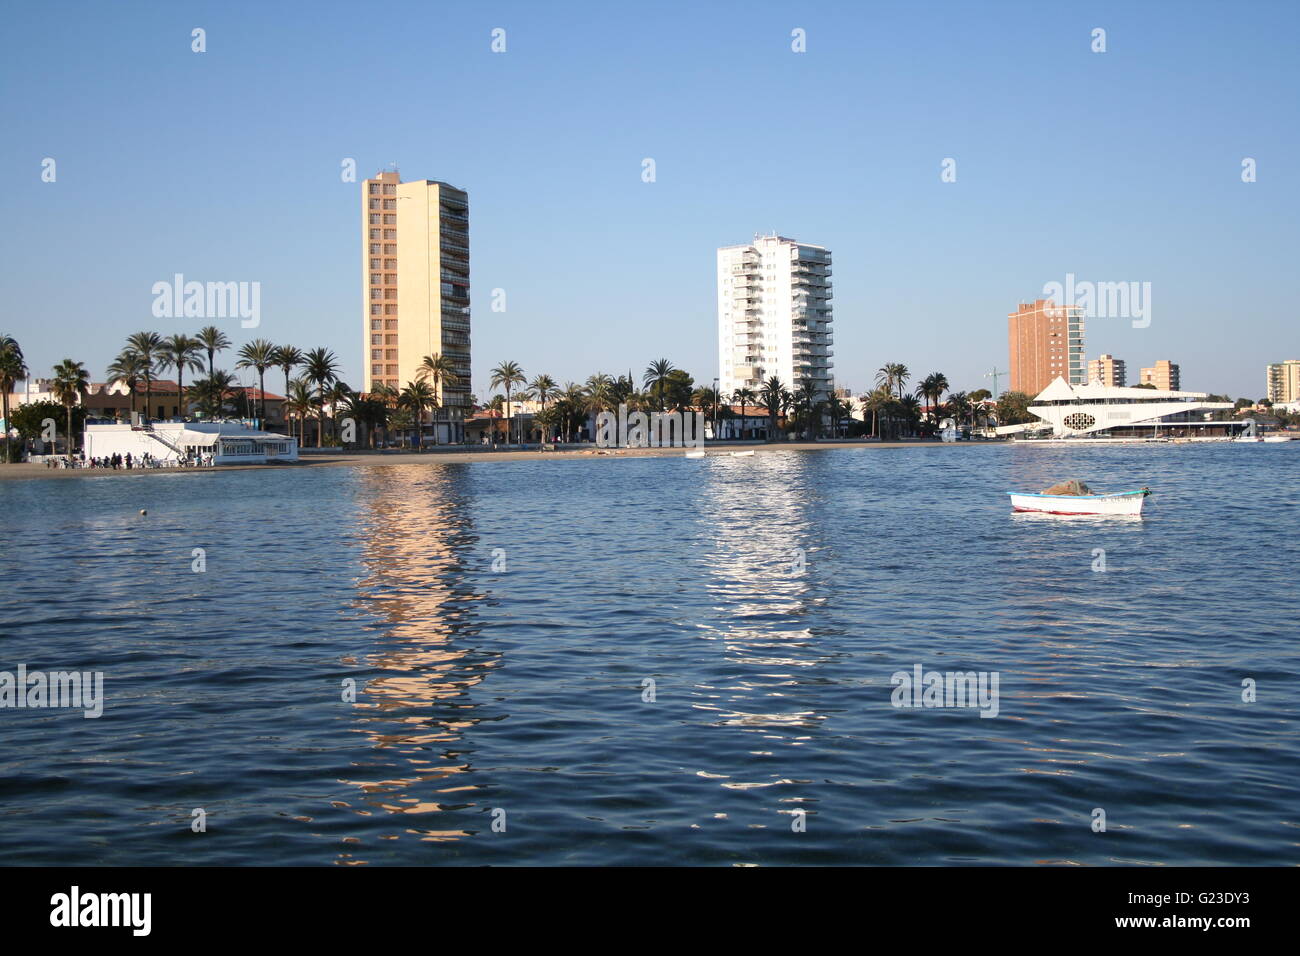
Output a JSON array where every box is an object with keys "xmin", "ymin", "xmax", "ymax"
[{"xmin": 345, "ymin": 464, "xmax": 499, "ymax": 862}]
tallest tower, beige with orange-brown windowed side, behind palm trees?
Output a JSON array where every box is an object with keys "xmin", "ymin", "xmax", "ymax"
[{"xmin": 361, "ymin": 172, "xmax": 469, "ymax": 442}]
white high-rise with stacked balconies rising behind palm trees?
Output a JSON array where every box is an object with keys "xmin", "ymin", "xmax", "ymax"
[{"xmin": 718, "ymin": 235, "xmax": 833, "ymax": 408}]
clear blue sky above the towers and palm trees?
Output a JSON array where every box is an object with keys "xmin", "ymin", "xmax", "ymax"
[{"xmin": 0, "ymin": 0, "xmax": 1300, "ymax": 397}]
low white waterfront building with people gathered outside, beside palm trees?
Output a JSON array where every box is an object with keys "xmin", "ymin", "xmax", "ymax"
[{"xmin": 85, "ymin": 421, "xmax": 298, "ymax": 464}]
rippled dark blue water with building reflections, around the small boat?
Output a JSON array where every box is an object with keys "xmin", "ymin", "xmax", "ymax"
[{"xmin": 0, "ymin": 442, "xmax": 1300, "ymax": 865}]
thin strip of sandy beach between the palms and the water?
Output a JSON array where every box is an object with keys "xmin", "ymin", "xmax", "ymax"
[{"xmin": 0, "ymin": 441, "xmax": 977, "ymax": 481}]
